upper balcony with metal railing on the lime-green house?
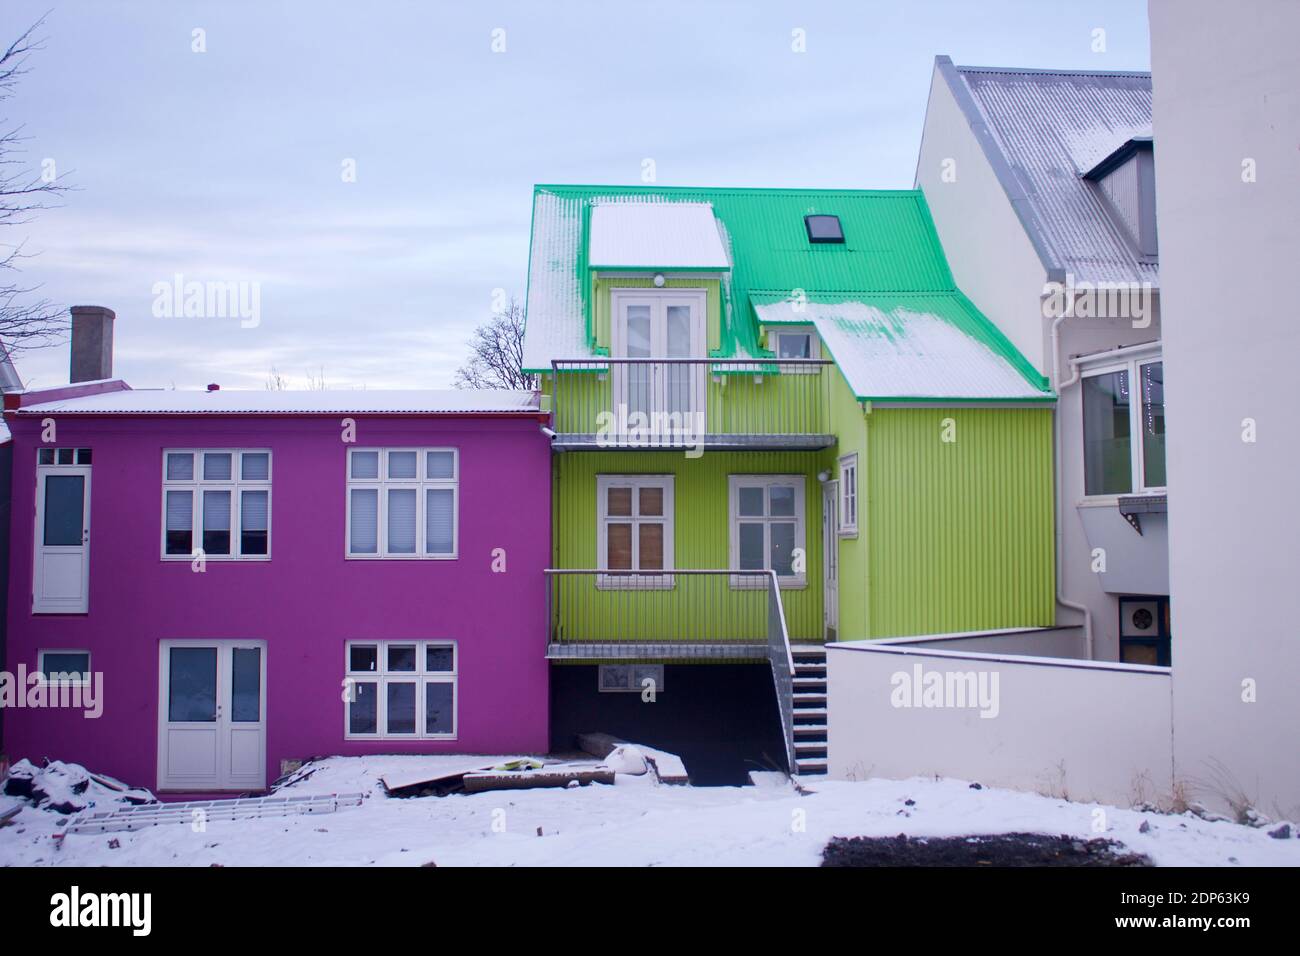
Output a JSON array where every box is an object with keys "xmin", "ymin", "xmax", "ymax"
[{"xmin": 551, "ymin": 358, "xmax": 835, "ymax": 451}]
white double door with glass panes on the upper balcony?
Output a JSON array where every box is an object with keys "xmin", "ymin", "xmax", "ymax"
[{"xmin": 611, "ymin": 289, "xmax": 707, "ymax": 438}]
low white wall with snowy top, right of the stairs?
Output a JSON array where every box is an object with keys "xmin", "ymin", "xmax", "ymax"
[{"xmin": 827, "ymin": 641, "xmax": 1173, "ymax": 806}]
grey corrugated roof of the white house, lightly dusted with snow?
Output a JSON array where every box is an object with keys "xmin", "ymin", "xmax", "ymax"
[{"xmin": 937, "ymin": 57, "xmax": 1160, "ymax": 285}]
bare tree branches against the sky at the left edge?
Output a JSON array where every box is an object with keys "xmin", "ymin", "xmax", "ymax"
[{"xmin": 0, "ymin": 17, "xmax": 69, "ymax": 352}]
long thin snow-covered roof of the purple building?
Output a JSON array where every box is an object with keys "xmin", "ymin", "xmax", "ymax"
[{"xmin": 17, "ymin": 389, "xmax": 540, "ymax": 415}]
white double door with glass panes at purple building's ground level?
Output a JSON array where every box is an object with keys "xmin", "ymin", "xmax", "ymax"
[{"xmin": 159, "ymin": 641, "xmax": 267, "ymax": 791}]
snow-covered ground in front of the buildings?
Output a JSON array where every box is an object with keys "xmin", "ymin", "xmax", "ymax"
[{"xmin": 0, "ymin": 757, "xmax": 1300, "ymax": 866}]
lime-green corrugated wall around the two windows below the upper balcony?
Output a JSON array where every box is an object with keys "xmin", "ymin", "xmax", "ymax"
[{"xmin": 553, "ymin": 451, "xmax": 822, "ymax": 640}]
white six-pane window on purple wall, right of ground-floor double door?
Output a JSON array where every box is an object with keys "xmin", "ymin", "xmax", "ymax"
[{"xmin": 343, "ymin": 640, "xmax": 459, "ymax": 740}]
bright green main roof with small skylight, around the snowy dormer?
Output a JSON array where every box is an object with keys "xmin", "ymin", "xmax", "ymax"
[{"xmin": 524, "ymin": 185, "xmax": 1045, "ymax": 392}]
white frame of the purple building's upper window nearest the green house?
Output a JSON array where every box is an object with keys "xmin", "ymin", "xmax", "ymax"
[{"xmin": 343, "ymin": 445, "xmax": 460, "ymax": 561}]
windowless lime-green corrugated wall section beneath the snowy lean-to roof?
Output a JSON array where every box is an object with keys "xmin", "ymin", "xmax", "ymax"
[{"xmin": 863, "ymin": 407, "xmax": 1056, "ymax": 639}]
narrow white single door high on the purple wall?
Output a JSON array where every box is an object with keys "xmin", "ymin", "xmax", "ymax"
[{"xmin": 31, "ymin": 464, "xmax": 90, "ymax": 614}]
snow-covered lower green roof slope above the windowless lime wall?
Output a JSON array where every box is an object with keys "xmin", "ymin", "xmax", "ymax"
[{"xmin": 754, "ymin": 297, "xmax": 1053, "ymax": 401}]
